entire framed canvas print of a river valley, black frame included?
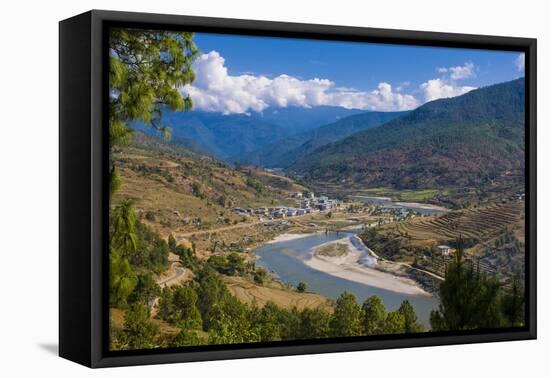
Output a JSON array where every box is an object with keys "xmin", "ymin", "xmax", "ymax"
[{"xmin": 59, "ymin": 10, "xmax": 536, "ymax": 367}]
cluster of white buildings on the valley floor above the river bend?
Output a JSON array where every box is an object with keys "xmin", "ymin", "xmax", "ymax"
[{"xmin": 233, "ymin": 192, "xmax": 342, "ymax": 219}]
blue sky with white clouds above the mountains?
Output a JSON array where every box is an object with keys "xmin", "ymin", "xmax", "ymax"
[{"xmin": 183, "ymin": 33, "xmax": 523, "ymax": 113}]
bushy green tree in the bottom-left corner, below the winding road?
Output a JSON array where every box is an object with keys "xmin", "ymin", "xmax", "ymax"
[{"xmin": 123, "ymin": 302, "xmax": 159, "ymax": 349}]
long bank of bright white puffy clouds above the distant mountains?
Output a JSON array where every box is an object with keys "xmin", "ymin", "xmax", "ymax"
[{"xmin": 181, "ymin": 51, "xmax": 419, "ymax": 114}]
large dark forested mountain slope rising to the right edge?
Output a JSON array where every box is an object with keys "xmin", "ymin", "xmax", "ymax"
[{"xmin": 288, "ymin": 78, "xmax": 525, "ymax": 189}]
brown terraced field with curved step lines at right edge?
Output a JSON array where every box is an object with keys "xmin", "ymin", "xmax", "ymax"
[{"xmin": 393, "ymin": 201, "xmax": 524, "ymax": 245}]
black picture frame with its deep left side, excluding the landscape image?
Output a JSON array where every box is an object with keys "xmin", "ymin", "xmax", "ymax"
[{"xmin": 59, "ymin": 10, "xmax": 537, "ymax": 368}]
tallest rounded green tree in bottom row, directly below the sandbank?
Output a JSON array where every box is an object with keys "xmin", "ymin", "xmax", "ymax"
[{"xmin": 330, "ymin": 291, "xmax": 363, "ymax": 337}]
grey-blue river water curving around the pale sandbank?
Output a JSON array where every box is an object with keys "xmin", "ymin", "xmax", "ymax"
[{"xmin": 255, "ymin": 233, "xmax": 439, "ymax": 328}]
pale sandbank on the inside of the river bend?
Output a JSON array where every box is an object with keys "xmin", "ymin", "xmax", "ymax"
[{"xmin": 304, "ymin": 236, "xmax": 431, "ymax": 296}]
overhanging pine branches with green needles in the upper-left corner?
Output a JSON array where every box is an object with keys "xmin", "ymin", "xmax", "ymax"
[{"xmin": 109, "ymin": 28, "xmax": 198, "ymax": 145}]
